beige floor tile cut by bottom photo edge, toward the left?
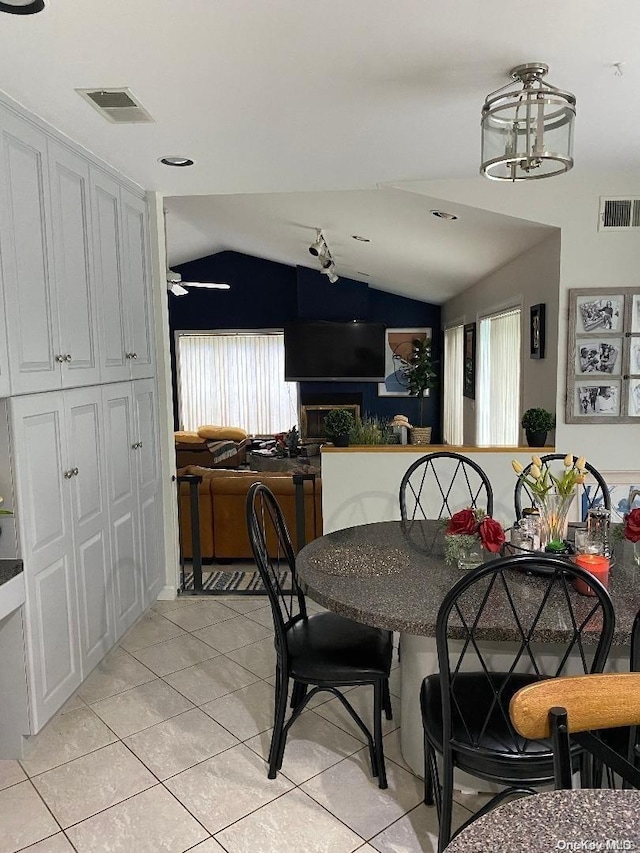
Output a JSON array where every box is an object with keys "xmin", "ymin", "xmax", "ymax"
[{"xmin": 67, "ymin": 785, "xmax": 207, "ymax": 853}]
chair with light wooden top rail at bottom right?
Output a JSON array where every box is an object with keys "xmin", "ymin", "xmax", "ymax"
[{"xmin": 509, "ymin": 672, "xmax": 640, "ymax": 790}]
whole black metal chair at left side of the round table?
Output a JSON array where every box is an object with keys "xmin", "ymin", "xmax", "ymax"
[{"xmin": 246, "ymin": 483, "xmax": 392, "ymax": 788}]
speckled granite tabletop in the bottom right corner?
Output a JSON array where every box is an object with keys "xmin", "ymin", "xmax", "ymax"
[{"xmin": 446, "ymin": 790, "xmax": 640, "ymax": 853}]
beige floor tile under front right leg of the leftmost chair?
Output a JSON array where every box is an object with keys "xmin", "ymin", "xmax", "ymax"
[{"xmin": 302, "ymin": 750, "xmax": 422, "ymax": 840}]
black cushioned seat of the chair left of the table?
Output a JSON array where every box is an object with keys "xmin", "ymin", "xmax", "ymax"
[{"xmin": 287, "ymin": 613, "xmax": 393, "ymax": 684}]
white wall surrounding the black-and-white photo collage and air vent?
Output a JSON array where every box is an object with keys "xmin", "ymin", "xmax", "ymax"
[{"xmin": 396, "ymin": 169, "xmax": 640, "ymax": 471}]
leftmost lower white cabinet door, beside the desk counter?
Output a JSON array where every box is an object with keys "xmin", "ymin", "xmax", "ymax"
[{"xmin": 11, "ymin": 392, "xmax": 82, "ymax": 732}]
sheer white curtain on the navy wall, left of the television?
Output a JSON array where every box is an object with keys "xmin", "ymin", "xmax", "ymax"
[{"xmin": 177, "ymin": 332, "xmax": 298, "ymax": 435}]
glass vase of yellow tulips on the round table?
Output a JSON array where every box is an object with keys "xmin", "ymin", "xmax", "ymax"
[{"xmin": 511, "ymin": 453, "xmax": 587, "ymax": 552}]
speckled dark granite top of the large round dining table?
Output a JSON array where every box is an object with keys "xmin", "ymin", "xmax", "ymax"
[{"xmin": 297, "ymin": 521, "xmax": 640, "ymax": 645}]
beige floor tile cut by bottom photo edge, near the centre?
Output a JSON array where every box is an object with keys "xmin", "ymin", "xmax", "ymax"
[{"xmin": 218, "ymin": 790, "xmax": 362, "ymax": 853}]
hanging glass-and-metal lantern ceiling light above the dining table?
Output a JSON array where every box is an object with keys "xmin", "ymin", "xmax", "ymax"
[{"xmin": 480, "ymin": 62, "xmax": 576, "ymax": 181}]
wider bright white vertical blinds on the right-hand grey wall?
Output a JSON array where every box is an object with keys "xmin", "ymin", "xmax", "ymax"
[{"xmin": 477, "ymin": 308, "xmax": 520, "ymax": 446}]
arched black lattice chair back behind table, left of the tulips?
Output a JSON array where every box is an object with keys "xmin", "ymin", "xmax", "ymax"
[{"xmin": 400, "ymin": 451, "xmax": 493, "ymax": 521}]
